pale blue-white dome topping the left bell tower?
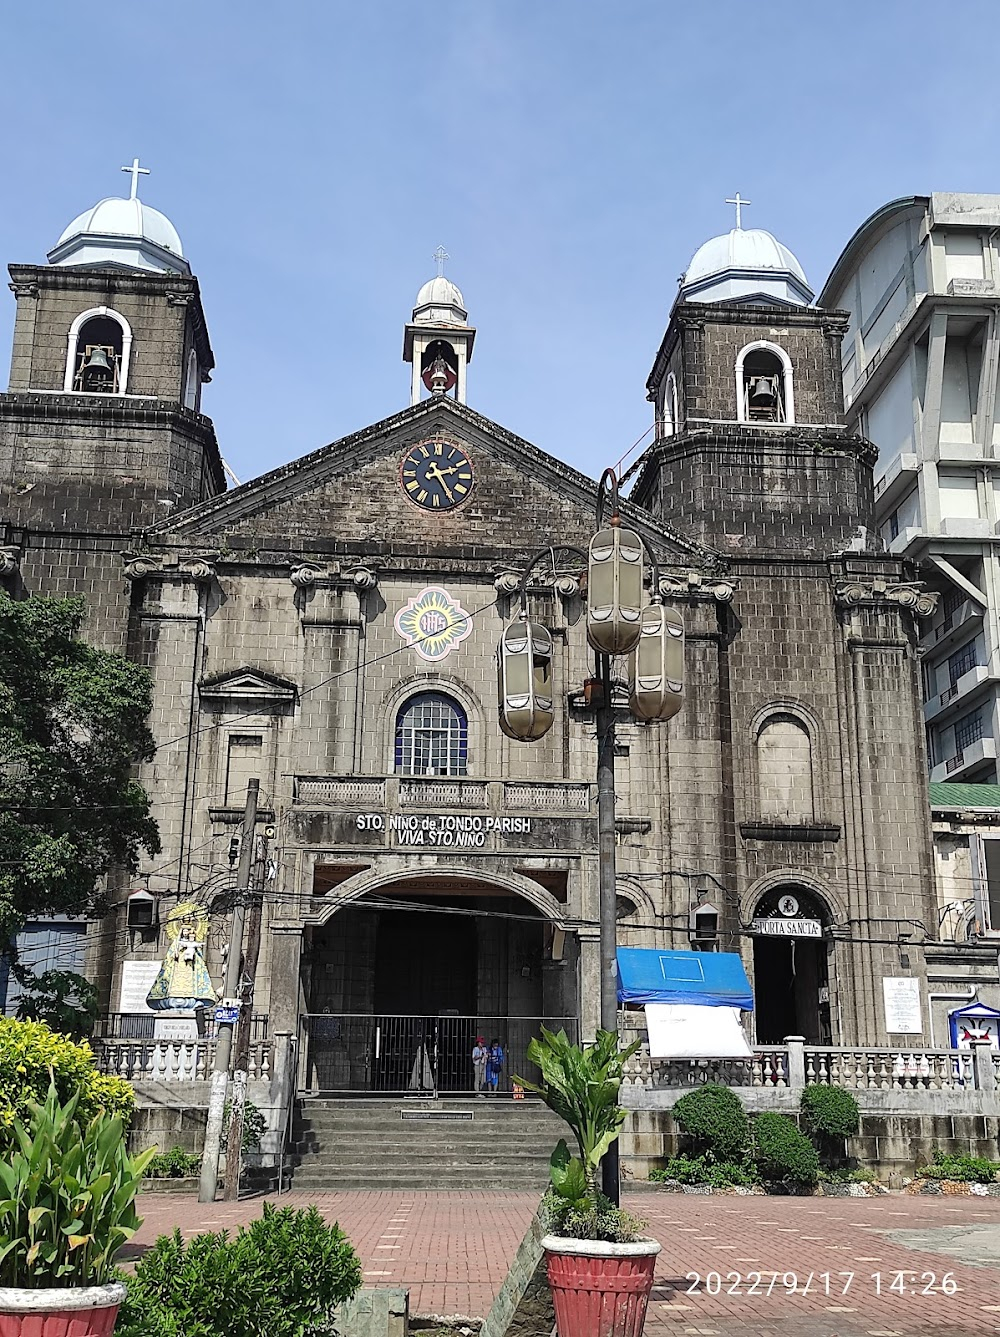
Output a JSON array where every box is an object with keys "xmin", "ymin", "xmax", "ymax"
[{"xmin": 48, "ymin": 195, "xmax": 190, "ymax": 273}]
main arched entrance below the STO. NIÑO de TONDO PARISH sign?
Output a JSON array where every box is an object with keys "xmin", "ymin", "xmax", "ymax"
[{"xmin": 303, "ymin": 866, "xmax": 576, "ymax": 1095}]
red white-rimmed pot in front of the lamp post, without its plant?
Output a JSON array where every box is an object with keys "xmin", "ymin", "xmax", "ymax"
[{"xmin": 542, "ymin": 1235, "xmax": 659, "ymax": 1337}]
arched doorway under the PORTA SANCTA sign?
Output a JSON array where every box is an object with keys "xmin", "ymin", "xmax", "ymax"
[{"xmin": 750, "ymin": 882, "xmax": 833, "ymax": 1044}]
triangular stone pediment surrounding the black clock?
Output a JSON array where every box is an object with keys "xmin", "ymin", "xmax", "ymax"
[{"xmin": 147, "ymin": 398, "xmax": 717, "ymax": 566}]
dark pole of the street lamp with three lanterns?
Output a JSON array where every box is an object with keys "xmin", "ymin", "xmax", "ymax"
[{"xmin": 596, "ymin": 655, "xmax": 622, "ymax": 1206}]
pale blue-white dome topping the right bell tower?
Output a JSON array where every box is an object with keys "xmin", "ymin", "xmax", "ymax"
[{"xmin": 680, "ymin": 227, "xmax": 813, "ymax": 306}]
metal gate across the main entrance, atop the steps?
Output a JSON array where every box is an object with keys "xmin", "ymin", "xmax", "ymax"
[{"xmin": 299, "ymin": 1012, "xmax": 578, "ymax": 1096}]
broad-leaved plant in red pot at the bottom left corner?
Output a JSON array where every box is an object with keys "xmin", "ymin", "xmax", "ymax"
[{"xmin": 0, "ymin": 1083, "xmax": 155, "ymax": 1337}]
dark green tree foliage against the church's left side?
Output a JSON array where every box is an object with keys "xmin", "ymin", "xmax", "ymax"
[{"xmin": 0, "ymin": 595, "xmax": 159, "ymax": 943}]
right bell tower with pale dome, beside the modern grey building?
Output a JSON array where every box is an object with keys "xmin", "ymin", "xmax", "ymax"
[{"xmin": 631, "ymin": 195, "xmax": 874, "ymax": 556}]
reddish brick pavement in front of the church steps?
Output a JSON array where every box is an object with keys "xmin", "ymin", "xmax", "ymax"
[{"xmin": 127, "ymin": 1190, "xmax": 1000, "ymax": 1337}]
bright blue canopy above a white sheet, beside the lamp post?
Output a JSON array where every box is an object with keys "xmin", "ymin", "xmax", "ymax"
[{"xmin": 618, "ymin": 947, "xmax": 754, "ymax": 1012}]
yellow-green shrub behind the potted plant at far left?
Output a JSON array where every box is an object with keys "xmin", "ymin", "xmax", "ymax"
[{"xmin": 0, "ymin": 1016, "xmax": 135, "ymax": 1152}]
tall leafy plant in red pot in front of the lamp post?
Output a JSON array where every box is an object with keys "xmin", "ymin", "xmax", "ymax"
[{"xmin": 516, "ymin": 1027, "xmax": 659, "ymax": 1337}]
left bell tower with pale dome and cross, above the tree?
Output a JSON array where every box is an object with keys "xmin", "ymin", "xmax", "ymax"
[{"xmin": 0, "ymin": 160, "xmax": 226, "ymax": 648}]
